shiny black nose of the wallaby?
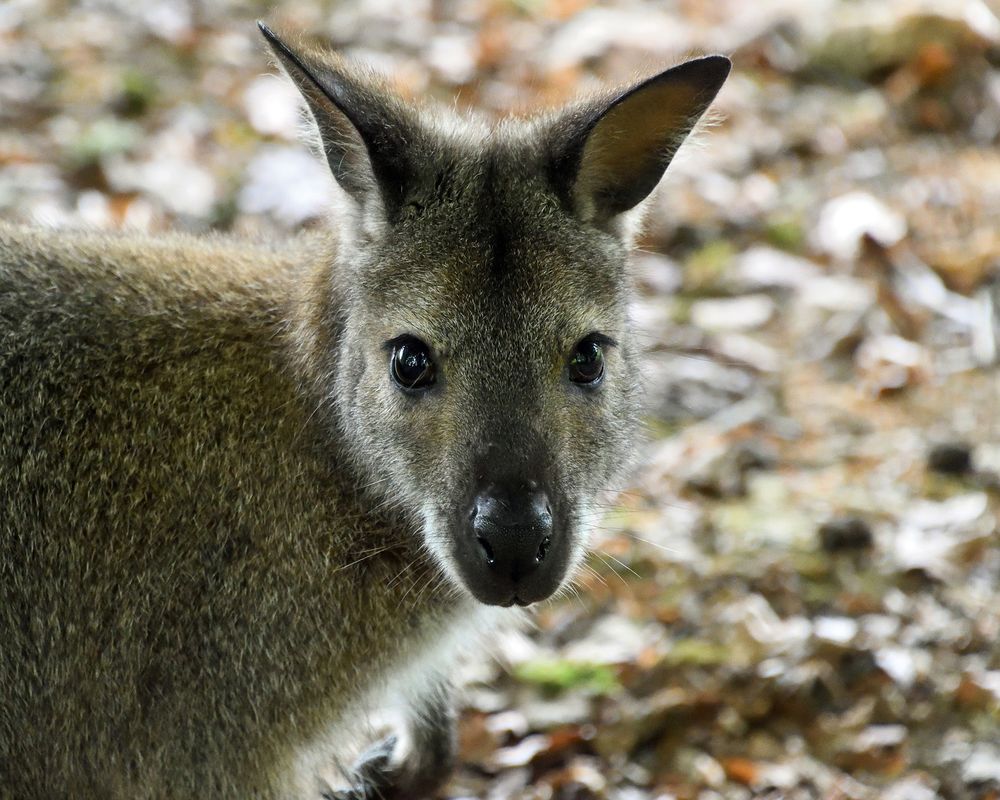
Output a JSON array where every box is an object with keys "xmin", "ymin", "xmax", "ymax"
[{"xmin": 470, "ymin": 486, "xmax": 552, "ymax": 593}]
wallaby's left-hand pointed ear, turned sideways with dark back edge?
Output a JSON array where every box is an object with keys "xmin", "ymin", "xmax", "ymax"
[{"xmin": 257, "ymin": 22, "xmax": 419, "ymax": 217}]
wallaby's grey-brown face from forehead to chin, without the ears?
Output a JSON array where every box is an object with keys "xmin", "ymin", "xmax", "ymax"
[{"xmin": 335, "ymin": 164, "xmax": 636, "ymax": 605}]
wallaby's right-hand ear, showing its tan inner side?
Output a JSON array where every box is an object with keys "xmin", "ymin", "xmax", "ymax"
[{"xmin": 552, "ymin": 56, "xmax": 732, "ymax": 225}]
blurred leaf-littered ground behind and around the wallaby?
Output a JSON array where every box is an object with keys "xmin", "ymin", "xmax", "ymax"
[{"xmin": 0, "ymin": 0, "xmax": 1000, "ymax": 800}]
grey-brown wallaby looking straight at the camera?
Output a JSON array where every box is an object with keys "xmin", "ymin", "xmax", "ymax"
[{"xmin": 0, "ymin": 25, "xmax": 730, "ymax": 800}]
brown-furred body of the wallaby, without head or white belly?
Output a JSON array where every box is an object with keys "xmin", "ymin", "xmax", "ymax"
[{"xmin": 0, "ymin": 228, "xmax": 456, "ymax": 798}]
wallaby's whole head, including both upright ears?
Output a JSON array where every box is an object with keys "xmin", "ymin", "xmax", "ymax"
[{"xmin": 261, "ymin": 25, "xmax": 730, "ymax": 605}]
